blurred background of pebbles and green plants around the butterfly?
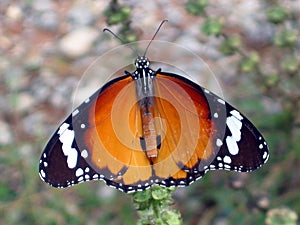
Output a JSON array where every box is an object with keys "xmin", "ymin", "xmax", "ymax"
[{"xmin": 0, "ymin": 0, "xmax": 300, "ymax": 225}]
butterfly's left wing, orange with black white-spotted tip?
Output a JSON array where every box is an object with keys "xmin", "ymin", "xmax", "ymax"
[{"xmin": 39, "ymin": 75, "xmax": 149, "ymax": 191}]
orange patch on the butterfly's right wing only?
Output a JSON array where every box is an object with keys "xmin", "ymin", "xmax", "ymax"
[{"xmin": 155, "ymin": 74, "xmax": 215, "ymax": 172}]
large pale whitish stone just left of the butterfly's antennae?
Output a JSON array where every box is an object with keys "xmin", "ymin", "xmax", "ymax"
[{"xmin": 59, "ymin": 27, "xmax": 99, "ymax": 58}]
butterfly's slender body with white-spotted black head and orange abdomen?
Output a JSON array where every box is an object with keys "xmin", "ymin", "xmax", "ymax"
[{"xmin": 131, "ymin": 56, "xmax": 160, "ymax": 162}]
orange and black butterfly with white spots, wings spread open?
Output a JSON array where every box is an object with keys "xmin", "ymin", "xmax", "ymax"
[{"xmin": 39, "ymin": 21, "xmax": 269, "ymax": 193}]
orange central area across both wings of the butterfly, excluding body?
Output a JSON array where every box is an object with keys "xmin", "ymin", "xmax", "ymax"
[{"xmin": 85, "ymin": 74, "xmax": 217, "ymax": 185}]
